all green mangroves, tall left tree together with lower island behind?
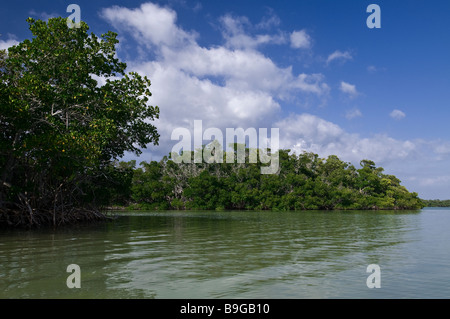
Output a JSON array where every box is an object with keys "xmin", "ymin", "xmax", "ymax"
[{"xmin": 0, "ymin": 18, "xmax": 424, "ymax": 226}]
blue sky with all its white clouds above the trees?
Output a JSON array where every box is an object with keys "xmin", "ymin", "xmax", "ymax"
[{"xmin": 0, "ymin": 0, "xmax": 450, "ymax": 199}]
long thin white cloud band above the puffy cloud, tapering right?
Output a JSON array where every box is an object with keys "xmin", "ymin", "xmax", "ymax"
[{"xmin": 163, "ymin": 45, "xmax": 329, "ymax": 98}]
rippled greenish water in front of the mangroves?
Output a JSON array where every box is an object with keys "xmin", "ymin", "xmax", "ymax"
[{"xmin": 0, "ymin": 208, "xmax": 450, "ymax": 299}]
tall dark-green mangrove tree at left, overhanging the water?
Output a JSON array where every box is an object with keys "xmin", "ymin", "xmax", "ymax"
[{"xmin": 0, "ymin": 18, "xmax": 159, "ymax": 228}]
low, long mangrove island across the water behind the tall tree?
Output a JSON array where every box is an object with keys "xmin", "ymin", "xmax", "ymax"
[{"xmin": 119, "ymin": 150, "xmax": 423, "ymax": 211}]
